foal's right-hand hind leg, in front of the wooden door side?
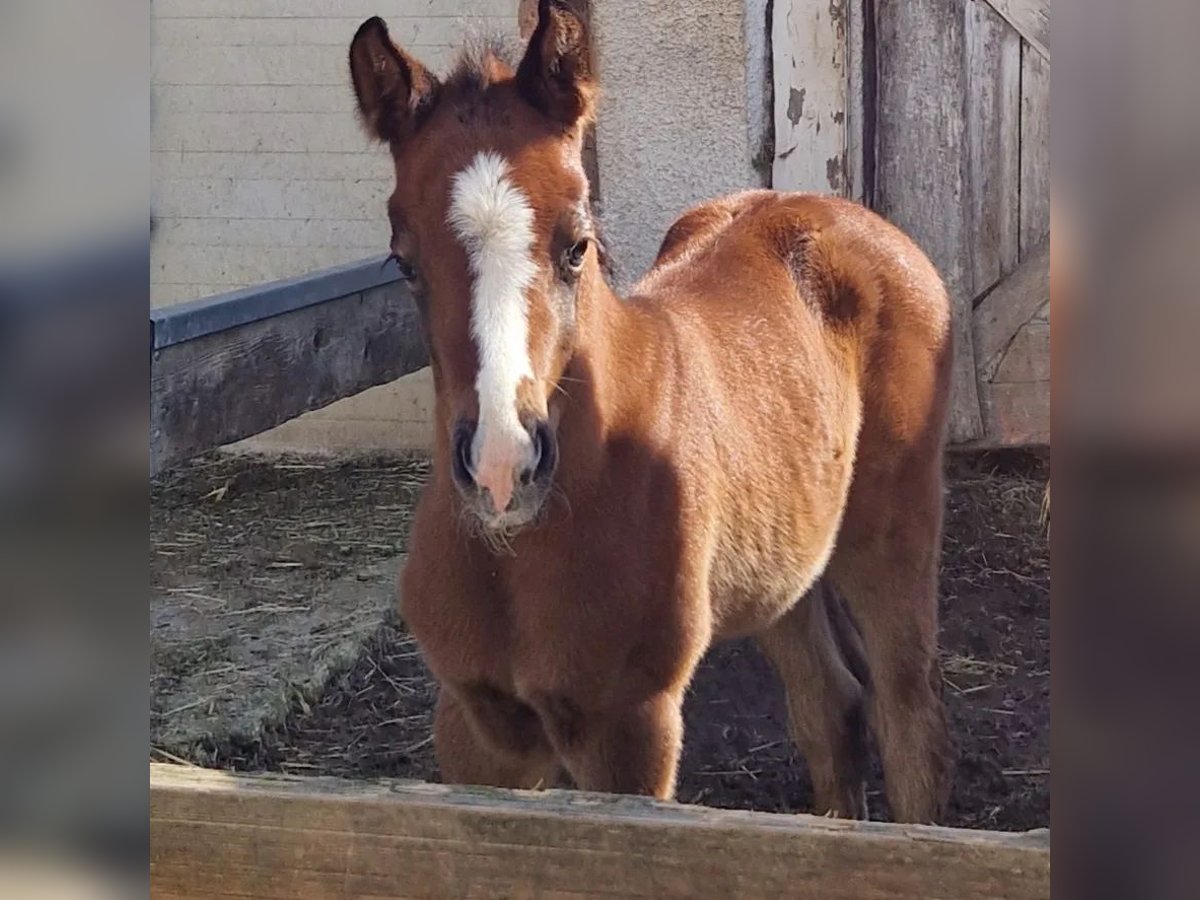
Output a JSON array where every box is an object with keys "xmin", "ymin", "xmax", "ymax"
[{"xmin": 828, "ymin": 458, "xmax": 953, "ymax": 822}]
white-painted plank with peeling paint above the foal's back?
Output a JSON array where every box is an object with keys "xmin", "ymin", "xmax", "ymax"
[{"xmin": 770, "ymin": 0, "xmax": 850, "ymax": 196}]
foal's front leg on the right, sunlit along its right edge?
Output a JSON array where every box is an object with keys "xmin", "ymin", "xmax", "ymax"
[{"xmin": 536, "ymin": 691, "xmax": 683, "ymax": 800}]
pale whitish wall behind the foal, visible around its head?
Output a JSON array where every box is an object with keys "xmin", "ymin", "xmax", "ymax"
[{"xmin": 151, "ymin": 0, "xmax": 769, "ymax": 452}]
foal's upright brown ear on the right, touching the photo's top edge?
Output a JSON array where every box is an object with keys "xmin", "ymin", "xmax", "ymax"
[{"xmin": 517, "ymin": 0, "xmax": 596, "ymax": 126}]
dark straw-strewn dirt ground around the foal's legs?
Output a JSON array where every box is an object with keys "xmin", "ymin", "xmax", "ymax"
[{"xmin": 151, "ymin": 455, "xmax": 1050, "ymax": 830}]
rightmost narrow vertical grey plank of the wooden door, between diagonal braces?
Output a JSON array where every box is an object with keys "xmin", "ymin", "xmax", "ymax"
[{"xmin": 1021, "ymin": 44, "xmax": 1050, "ymax": 258}]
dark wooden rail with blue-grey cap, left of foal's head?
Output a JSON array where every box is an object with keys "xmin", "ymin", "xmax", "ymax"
[{"xmin": 150, "ymin": 257, "xmax": 427, "ymax": 474}]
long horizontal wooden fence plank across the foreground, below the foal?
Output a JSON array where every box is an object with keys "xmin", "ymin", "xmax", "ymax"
[{"xmin": 150, "ymin": 764, "xmax": 1050, "ymax": 900}]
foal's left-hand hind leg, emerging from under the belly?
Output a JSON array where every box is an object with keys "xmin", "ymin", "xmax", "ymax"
[{"xmin": 757, "ymin": 581, "xmax": 868, "ymax": 818}]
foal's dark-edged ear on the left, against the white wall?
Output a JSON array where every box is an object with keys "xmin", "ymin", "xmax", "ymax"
[{"xmin": 350, "ymin": 16, "xmax": 438, "ymax": 142}]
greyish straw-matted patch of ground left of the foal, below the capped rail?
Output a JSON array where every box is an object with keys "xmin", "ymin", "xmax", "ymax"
[{"xmin": 150, "ymin": 454, "xmax": 428, "ymax": 755}]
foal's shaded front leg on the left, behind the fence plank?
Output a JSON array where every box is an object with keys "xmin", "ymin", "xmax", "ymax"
[{"xmin": 433, "ymin": 688, "xmax": 560, "ymax": 788}]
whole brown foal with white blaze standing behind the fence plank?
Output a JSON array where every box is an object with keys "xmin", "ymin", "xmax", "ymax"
[{"xmin": 350, "ymin": 0, "xmax": 949, "ymax": 820}]
